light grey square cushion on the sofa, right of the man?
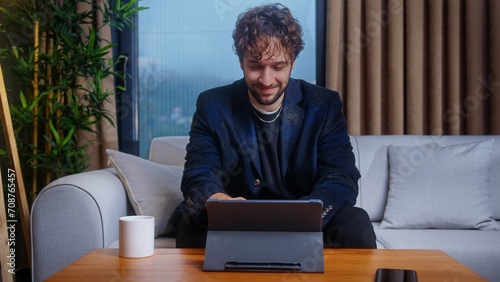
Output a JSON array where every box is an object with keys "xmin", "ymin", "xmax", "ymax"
[{"xmin": 381, "ymin": 140, "xmax": 500, "ymax": 230}]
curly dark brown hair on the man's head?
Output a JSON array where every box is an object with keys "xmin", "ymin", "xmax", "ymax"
[{"xmin": 233, "ymin": 4, "xmax": 304, "ymax": 62}]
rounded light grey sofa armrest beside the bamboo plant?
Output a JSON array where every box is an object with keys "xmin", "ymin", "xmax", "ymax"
[{"xmin": 31, "ymin": 169, "xmax": 131, "ymax": 281}]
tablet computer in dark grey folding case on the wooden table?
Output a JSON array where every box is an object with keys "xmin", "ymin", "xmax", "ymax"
[{"xmin": 203, "ymin": 200, "xmax": 324, "ymax": 272}]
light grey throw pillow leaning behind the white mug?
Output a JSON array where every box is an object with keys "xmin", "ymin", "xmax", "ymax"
[{"xmin": 106, "ymin": 149, "xmax": 183, "ymax": 237}]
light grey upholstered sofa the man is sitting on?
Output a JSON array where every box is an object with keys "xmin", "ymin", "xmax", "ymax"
[{"xmin": 31, "ymin": 135, "xmax": 500, "ymax": 281}]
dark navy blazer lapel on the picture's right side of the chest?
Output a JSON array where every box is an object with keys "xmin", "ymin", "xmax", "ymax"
[{"xmin": 279, "ymin": 78, "xmax": 304, "ymax": 179}]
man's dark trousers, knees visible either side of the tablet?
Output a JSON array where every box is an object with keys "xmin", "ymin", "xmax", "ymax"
[{"xmin": 176, "ymin": 207, "xmax": 377, "ymax": 249}]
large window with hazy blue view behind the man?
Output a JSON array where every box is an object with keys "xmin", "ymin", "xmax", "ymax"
[{"xmin": 117, "ymin": 0, "xmax": 317, "ymax": 157}]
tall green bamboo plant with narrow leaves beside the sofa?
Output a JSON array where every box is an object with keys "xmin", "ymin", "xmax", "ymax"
[{"xmin": 0, "ymin": 0, "xmax": 145, "ymax": 203}]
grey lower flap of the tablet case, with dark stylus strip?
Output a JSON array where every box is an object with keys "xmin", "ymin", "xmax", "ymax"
[{"xmin": 203, "ymin": 231, "xmax": 324, "ymax": 273}]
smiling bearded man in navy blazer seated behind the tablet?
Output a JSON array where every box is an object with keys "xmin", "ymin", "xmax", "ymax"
[{"xmin": 177, "ymin": 5, "xmax": 376, "ymax": 248}]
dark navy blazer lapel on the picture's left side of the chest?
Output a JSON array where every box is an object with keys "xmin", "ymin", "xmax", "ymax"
[{"xmin": 233, "ymin": 79, "xmax": 262, "ymax": 176}]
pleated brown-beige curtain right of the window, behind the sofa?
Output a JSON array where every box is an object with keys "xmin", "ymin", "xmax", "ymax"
[{"xmin": 326, "ymin": 0, "xmax": 500, "ymax": 135}]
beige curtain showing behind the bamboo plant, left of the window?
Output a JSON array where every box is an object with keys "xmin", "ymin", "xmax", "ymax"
[{"xmin": 77, "ymin": 0, "xmax": 118, "ymax": 170}]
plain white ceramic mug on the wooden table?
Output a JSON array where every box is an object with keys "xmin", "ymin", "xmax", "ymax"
[{"xmin": 118, "ymin": 215, "xmax": 155, "ymax": 258}]
